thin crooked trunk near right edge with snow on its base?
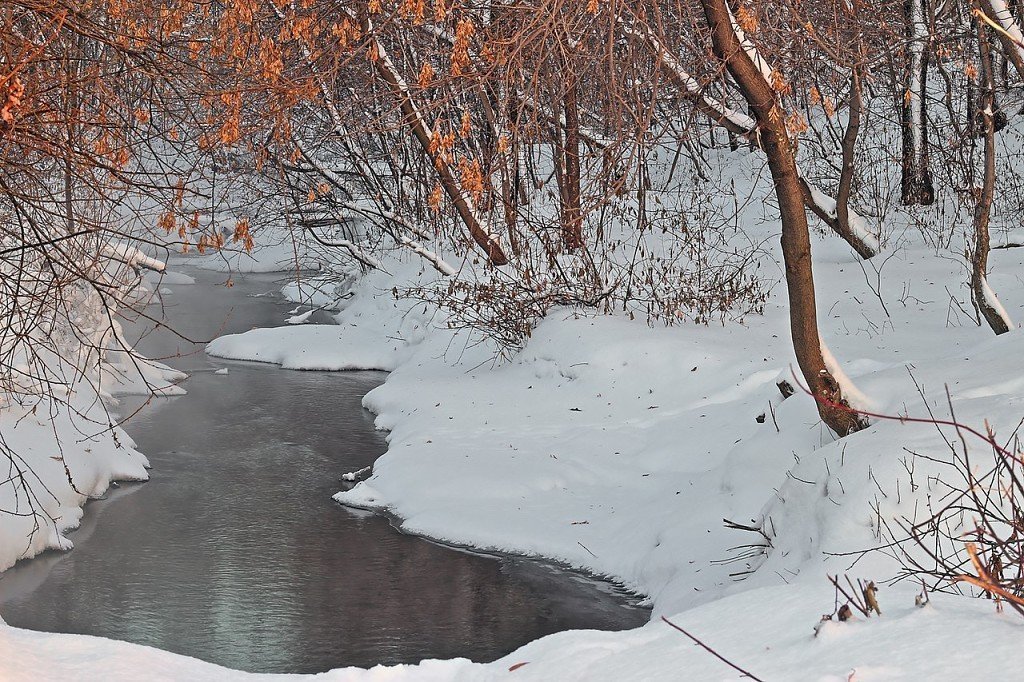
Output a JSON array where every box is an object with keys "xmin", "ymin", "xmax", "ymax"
[{"xmin": 971, "ymin": 14, "xmax": 1013, "ymax": 334}]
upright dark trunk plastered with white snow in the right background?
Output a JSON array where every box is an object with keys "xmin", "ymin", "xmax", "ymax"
[{"xmin": 900, "ymin": 0, "xmax": 935, "ymax": 206}]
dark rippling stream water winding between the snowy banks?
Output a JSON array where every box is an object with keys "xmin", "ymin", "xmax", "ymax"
[{"xmin": 0, "ymin": 262, "xmax": 648, "ymax": 672}]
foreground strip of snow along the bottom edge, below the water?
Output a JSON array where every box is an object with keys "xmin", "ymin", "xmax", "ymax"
[{"xmin": 0, "ymin": 586, "xmax": 1024, "ymax": 682}]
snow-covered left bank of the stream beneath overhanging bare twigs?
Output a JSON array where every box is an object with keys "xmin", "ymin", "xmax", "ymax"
[{"xmin": 0, "ymin": 253, "xmax": 184, "ymax": 570}]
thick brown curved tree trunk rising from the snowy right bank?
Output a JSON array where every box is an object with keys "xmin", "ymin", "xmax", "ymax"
[{"xmin": 701, "ymin": 0, "xmax": 866, "ymax": 436}]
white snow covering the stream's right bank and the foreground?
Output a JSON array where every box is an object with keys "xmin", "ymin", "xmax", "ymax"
[{"xmin": 9, "ymin": 168, "xmax": 1024, "ymax": 680}]
